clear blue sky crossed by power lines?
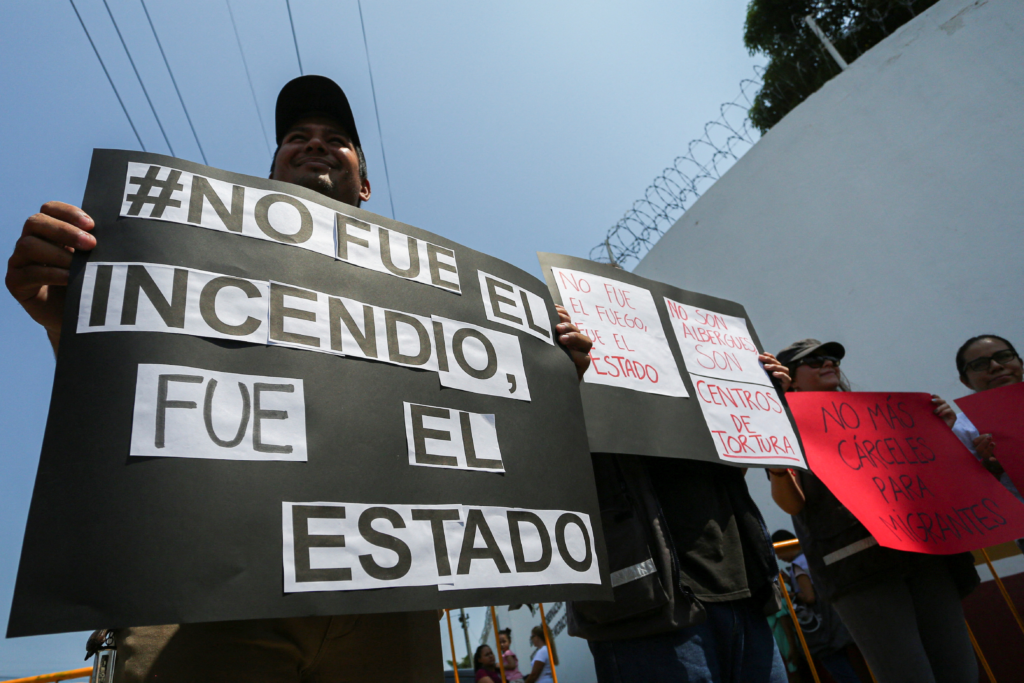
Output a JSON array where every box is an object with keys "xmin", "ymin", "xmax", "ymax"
[{"xmin": 0, "ymin": 0, "xmax": 760, "ymax": 680}]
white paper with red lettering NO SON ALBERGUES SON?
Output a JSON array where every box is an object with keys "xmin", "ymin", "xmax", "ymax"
[{"xmin": 665, "ymin": 297, "xmax": 771, "ymax": 386}]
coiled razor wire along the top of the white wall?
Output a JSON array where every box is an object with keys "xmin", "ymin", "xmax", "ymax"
[{"xmin": 588, "ymin": 0, "xmax": 937, "ymax": 268}]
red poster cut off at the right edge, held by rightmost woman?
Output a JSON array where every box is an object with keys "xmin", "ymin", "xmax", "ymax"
[{"xmin": 956, "ymin": 382, "xmax": 1024, "ymax": 490}]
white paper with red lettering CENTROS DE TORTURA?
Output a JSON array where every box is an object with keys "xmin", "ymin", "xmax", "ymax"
[{"xmin": 690, "ymin": 374, "xmax": 807, "ymax": 468}]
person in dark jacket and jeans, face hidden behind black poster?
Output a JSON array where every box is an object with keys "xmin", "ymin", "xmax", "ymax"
[{"xmin": 569, "ymin": 354, "xmax": 788, "ymax": 683}]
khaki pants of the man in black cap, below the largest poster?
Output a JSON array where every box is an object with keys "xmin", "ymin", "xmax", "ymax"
[{"xmin": 114, "ymin": 610, "xmax": 443, "ymax": 683}]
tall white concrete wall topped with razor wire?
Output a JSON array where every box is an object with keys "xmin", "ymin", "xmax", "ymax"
[{"xmin": 635, "ymin": 0, "xmax": 1024, "ymax": 529}]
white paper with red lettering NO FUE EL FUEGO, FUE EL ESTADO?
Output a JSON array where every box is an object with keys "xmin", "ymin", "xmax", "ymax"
[{"xmin": 552, "ymin": 268, "xmax": 688, "ymax": 397}]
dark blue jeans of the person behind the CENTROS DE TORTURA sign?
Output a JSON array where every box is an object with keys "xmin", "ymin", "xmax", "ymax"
[{"xmin": 589, "ymin": 600, "xmax": 787, "ymax": 683}]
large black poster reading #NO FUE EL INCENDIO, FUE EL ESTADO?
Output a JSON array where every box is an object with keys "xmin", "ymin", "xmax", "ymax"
[{"xmin": 8, "ymin": 151, "xmax": 609, "ymax": 636}]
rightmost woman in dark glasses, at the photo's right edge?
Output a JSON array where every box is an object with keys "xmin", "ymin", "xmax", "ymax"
[{"xmin": 953, "ymin": 335, "xmax": 1024, "ymax": 511}]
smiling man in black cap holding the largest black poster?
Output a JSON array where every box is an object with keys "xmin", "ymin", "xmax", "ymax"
[{"xmin": 6, "ymin": 76, "xmax": 590, "ymax": 683}]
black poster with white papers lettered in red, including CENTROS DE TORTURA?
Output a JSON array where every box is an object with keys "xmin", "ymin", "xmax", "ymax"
[{"xmin": 539, "ymin": 254, "xmax": 806, "ymax": 468}]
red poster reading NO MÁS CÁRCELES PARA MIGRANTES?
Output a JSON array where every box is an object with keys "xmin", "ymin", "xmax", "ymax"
[{"xmin": 786, "ymin": 391, "xmax": 1024, "ymax": 555}]
